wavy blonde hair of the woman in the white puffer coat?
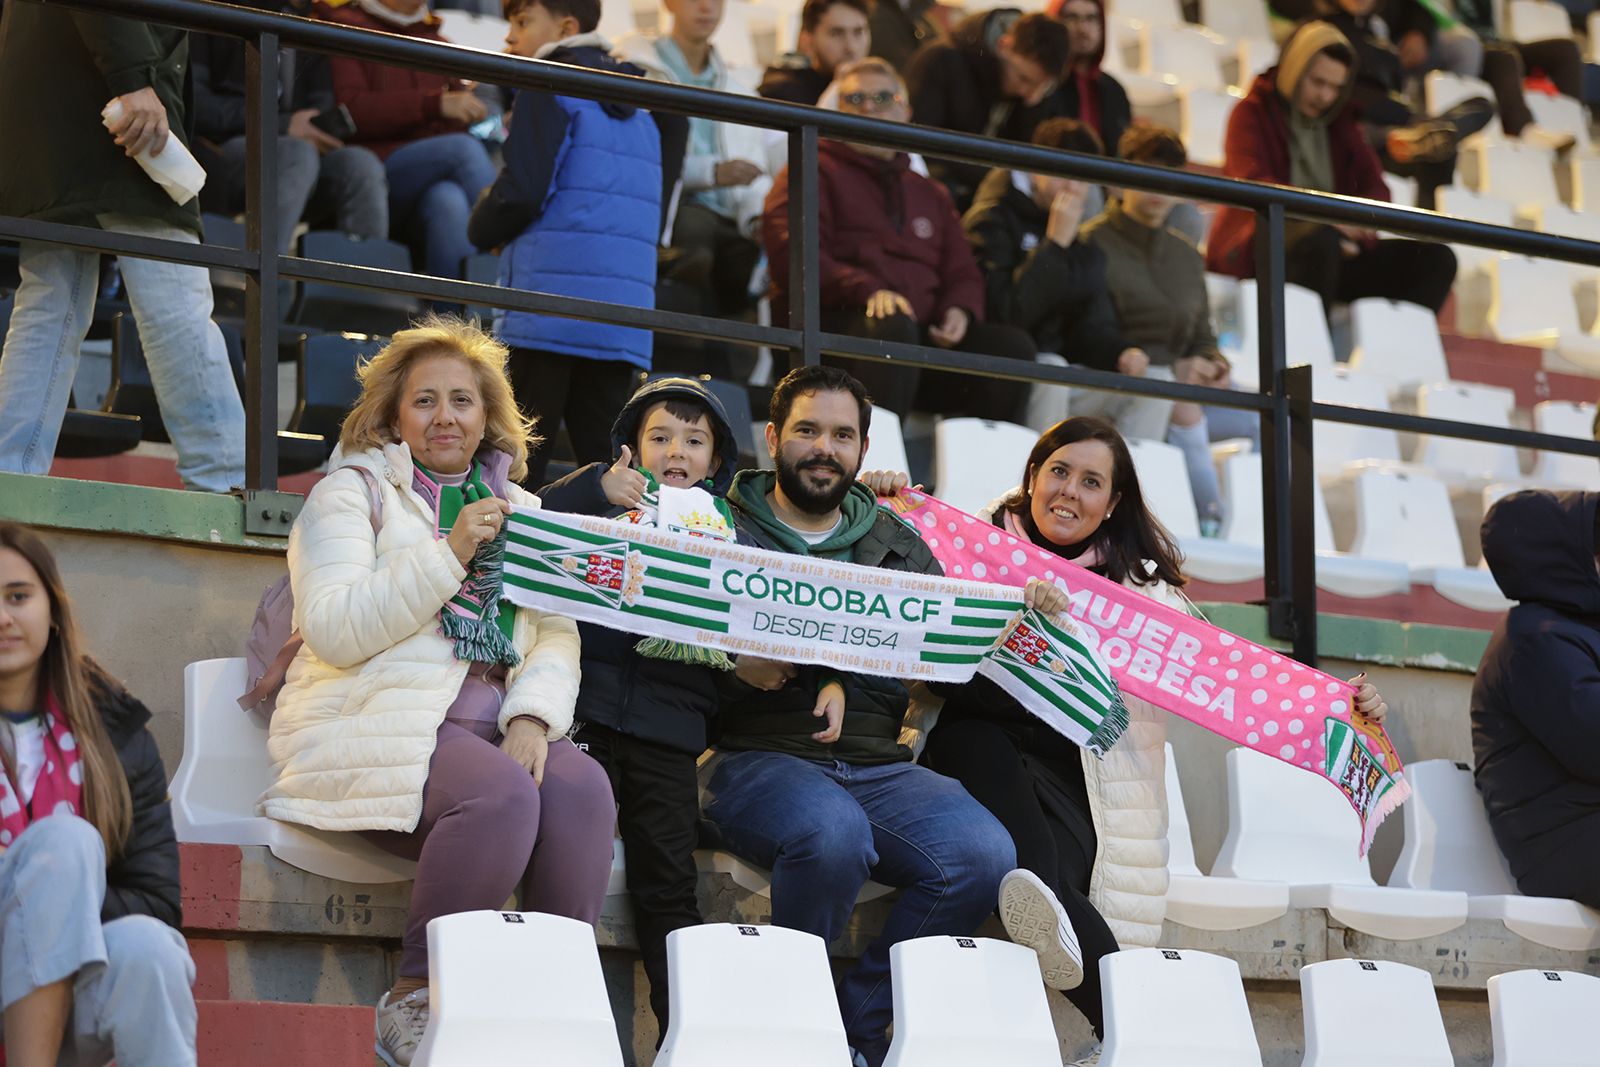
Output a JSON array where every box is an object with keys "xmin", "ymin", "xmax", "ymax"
[{"xmin": 339, "ymin": 315, "xmax": 541, "ymax": 482}]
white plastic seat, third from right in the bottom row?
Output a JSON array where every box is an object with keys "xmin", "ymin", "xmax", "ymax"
[{"xmin": 1099, "ymin": 949, "xmax": 1261, "ymax": 1067}]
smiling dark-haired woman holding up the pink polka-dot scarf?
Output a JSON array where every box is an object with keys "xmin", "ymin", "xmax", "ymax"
[{"xmin": 862, "ymin": 416, "xmax": 1387, "ymax": 1065}]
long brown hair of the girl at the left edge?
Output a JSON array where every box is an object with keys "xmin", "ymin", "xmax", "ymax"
[{"xmin": 0, "ymin": 523, "xmax": 133, "ymax": 861}]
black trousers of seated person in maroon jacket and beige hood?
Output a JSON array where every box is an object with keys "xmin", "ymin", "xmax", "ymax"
[{"xmin": 1283, "ymin": 222, "xmax": 1456, "ymax": 314}]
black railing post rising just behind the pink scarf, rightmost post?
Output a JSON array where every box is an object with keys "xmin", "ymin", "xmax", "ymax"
[{"xmin": 1254, "ymin": 203, "xmax": 1309, "ymax": 652}]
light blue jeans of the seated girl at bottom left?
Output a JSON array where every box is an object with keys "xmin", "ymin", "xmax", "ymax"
[{"xmin": 0, "ymin": 814, "xmax": 197, "ymax": 1067}]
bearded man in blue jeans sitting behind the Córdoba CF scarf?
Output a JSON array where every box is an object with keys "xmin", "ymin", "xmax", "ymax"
[{"xmin": 702, "ymin": 363, "xmax": 1017, "ymax": 1067}]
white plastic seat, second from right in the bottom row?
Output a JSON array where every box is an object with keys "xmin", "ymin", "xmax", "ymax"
[{"xmin": 1301, "ymin": 960, "xmax": 1456, "ymax": 1067}]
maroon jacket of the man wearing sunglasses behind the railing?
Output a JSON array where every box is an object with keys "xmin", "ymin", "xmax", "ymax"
[{"xmin": 762, "ymin": 141, "xmax": 984, "ymax": 325}]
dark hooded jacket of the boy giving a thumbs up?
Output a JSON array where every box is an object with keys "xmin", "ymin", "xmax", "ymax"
[{"xmin": 539, "ymin": 378, "xmax": 750, "ymax": 755}]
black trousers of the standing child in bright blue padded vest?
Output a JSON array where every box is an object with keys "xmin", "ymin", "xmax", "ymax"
[{"xmin": 510, "ymin": 349, "xmax": 638, "ymax": 491}]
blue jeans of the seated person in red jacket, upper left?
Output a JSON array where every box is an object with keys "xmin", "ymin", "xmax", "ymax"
[{"xmin": 384, "ymin": 133, "xmax": 494, "ymax": 278}]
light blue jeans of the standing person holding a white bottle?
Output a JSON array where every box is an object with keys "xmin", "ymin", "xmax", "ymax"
[{"xmin": 0, "ymin": 214, "xmax": 245, "ymax": 493}]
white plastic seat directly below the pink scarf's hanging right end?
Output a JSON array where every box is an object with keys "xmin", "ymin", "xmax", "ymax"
[{"xmin": 1211, "ymin": 748, "xmax": 1467, "ymax": 941}]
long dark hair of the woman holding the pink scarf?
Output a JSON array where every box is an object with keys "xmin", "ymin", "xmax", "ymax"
[{"xmin": 1002, "ymin": 414, "xmax": 1189, "ymax": 589}]
